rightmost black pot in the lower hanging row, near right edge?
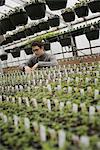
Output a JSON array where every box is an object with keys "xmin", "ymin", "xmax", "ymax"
[{"xmin": 85, "ymin": 29, "xmax": 99, "ymax": 41}]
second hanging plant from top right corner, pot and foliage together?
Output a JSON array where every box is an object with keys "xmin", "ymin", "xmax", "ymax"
[{"xmin": 74, "ymin": 0, "xmax": 89, "ymax": 18}]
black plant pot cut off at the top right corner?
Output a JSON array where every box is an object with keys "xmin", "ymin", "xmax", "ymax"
[{"xmin": 88, "ymin": 0, "xmax": 100, "ymax": 13}]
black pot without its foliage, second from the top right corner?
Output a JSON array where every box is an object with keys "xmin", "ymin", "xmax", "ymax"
[{"xmin": 74, "ymin": 6, "xmax": 89, "ymax": 18}]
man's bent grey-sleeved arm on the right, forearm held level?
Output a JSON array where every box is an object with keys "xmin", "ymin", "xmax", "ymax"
[{"xmin": 38, "ymin": 55, "xmax": 58, "ymax": 67}]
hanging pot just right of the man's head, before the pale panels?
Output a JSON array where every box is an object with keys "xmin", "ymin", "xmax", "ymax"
[{"xmin": 58, "ymin": 33, "xmax": 71, "ymax": 47}]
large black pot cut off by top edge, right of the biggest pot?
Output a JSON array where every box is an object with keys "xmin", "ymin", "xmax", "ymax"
[{"xmin": 46, "ymin": 0, "xmax": 67, "ymax": 10}]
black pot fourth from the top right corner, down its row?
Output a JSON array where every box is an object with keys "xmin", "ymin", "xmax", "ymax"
[{"xmin": 48, "ymin": 15, "xmax": 60, "ymax": 27}]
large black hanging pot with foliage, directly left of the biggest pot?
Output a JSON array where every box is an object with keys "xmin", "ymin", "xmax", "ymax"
[{"xmin": 9, "ymin": 7, "xmax": 28, "ymax": 26}]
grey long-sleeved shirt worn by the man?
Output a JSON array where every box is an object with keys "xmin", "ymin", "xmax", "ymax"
[{"xmin": 20, "ymin": 53, "xmax": 58, "ymax": 70}]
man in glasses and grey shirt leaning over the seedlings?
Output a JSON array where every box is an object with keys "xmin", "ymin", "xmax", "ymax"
[{"xmin": 20, "ymin": 42, "xmax": 58, "ymax": 73}]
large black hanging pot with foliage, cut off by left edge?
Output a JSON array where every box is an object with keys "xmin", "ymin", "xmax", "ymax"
[{"xmin": 0, "ymin": 14, "xmax": 16, "ymax": 34}]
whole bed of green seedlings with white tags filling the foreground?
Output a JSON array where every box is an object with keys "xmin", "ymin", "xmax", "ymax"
[{"xmin": 0, "ymin": 62, "xmax": 100, "ymax": 150}]
